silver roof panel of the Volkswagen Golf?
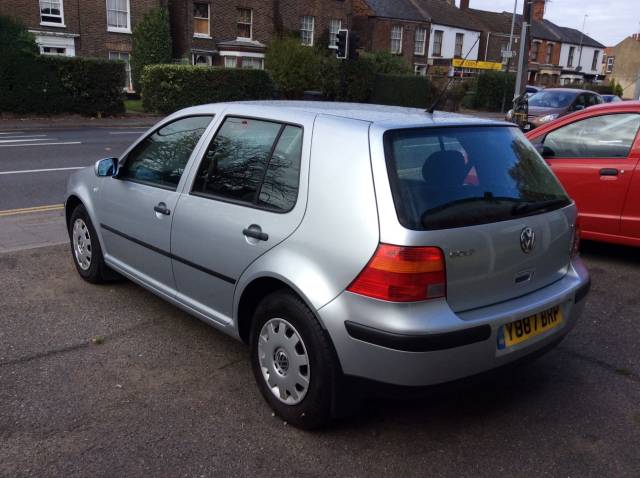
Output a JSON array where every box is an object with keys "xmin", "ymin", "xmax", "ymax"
[{"xmin": 179, "ymin": 100, "xmax": 510, "ymax": 128}]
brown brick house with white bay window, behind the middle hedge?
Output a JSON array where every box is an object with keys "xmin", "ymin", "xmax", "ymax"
[{"xmin": 169, "ymin": 0, "xmax": 351, "ymax": 68}]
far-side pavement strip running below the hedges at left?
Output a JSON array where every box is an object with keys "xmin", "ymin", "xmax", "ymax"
[{"xmin": 0, "ymin": 114, "xmax": 163, "ymax": 131}]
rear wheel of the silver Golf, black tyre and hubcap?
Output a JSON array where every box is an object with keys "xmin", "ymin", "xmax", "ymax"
[{"xmin": 250, "ymin": 291, "xmax": 339, "ymax": 430}]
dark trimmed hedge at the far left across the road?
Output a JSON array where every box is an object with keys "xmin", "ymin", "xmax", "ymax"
[{"xmin": 0, "ymin": 54, "xmax": 125, "ymax": 116}]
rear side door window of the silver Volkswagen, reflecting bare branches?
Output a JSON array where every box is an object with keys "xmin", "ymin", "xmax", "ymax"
[{"xmin": 192, "ymin": 117, "xmax": 302, "ymax": 212}]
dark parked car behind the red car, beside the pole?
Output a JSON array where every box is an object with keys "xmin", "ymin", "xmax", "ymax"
[{"xmin": 507, "ymin": 88, "xmax": 604, "ymax": 131}]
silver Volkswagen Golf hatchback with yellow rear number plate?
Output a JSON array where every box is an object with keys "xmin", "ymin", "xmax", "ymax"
[{"xmin": 66, "ymin": 102, "xmax": 590, "ymax": 428}]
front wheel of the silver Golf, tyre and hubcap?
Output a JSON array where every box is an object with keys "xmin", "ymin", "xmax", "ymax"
[{"xmin": 69, "ymin": 204, "xmax": 122, "ymax": 284}]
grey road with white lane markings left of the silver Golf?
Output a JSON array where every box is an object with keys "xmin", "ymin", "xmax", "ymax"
[{"xmin": 0, "ymin": 127, "xmax": 147, "ymax": 212}]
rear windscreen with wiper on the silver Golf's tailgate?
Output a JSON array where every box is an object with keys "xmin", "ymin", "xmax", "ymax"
[{"xmin": 384, "ymin": 126, "xmax": 571, "ymax": 230}]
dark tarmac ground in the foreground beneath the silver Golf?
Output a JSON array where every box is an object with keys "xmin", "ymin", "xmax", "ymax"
[{"xmin": 0, "ymin": 244, "xmax": 640, "ymax": 478}]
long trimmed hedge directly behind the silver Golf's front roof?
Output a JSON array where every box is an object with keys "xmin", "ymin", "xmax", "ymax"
[{"xmin": 141, "ymin": 65, "xmax": 274, "ymax": 114}]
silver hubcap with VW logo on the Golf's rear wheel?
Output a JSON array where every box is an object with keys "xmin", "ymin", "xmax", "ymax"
[{"xmin": 258, "ymin": 319, "xmax": 311, "ymax": 405}]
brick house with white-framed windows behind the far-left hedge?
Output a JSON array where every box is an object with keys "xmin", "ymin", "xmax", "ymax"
[{"xmin": 0, "ymin": 0, "xmax": 167, "ymax": 90}]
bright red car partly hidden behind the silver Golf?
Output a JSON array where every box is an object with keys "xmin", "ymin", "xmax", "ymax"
[{"xmin": 527, "ymin": 101, "xmax": 640, "ymax": 246}]
